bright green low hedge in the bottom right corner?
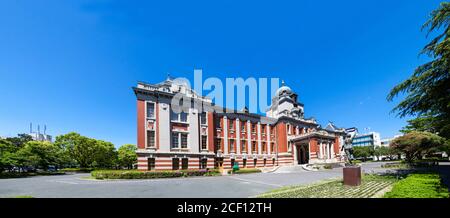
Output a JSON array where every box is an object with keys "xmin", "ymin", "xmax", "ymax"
[{"xmin": 384, "ymin": 173, "xmax": 449, "ymax": 198}]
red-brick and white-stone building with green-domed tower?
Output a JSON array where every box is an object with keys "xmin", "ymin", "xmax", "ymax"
[{"xmin": 133, "ymin": 78, "xmax": 345, "ymax": 170}]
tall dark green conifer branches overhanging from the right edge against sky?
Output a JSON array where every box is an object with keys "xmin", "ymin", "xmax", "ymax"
[{"xmin": 387, "ymin": 2, "xmax": 450, "ymax": 139}]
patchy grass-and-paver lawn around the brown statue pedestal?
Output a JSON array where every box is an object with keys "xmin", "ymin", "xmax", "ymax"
[{"xmin": 257, "ymin": 175, "xmax": 397, "ymax": 198}]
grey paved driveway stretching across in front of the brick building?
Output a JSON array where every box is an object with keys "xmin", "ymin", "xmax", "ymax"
[{"xmin": 0, "ymin": 163, "xmax": 381, "ymax": 198}]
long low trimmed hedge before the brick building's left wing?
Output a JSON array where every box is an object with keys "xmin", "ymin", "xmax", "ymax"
[{"xmin": 91, "ymin": 170, "xmax": 220, "ymax": 179}]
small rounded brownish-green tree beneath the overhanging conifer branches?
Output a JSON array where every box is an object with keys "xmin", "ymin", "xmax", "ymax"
[{"xmin": 391, "ymin": 131, "xmax": 445, "ymax": 163}]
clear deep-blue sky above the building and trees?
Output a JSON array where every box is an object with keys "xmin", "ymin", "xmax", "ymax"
[{"xmin": 0, "ymin": 0, "xmax": 440, "ymax": 146}]
